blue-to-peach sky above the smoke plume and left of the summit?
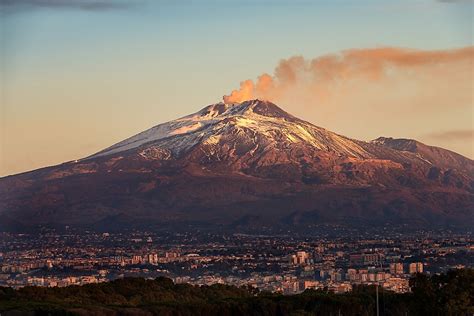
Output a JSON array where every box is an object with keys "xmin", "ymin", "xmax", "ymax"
[{"xmin": 0, "ymin": 0, "xmax": 473, "ymax": 176}]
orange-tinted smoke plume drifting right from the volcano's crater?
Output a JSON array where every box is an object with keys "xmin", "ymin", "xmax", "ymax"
[{"xmin": 224, "ymin": 47, "xmax": 474, "ymax": 103}]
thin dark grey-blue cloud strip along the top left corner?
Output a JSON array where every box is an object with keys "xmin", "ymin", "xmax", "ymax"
[{"xmin": 0, "ymin": 0, "xmax": 137, "ymax": 11}]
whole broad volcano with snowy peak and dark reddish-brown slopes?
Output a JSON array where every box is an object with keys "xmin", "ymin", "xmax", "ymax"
[{"xmin": 0, "ymin": 100, "xmax": 474, "ymax": 231}]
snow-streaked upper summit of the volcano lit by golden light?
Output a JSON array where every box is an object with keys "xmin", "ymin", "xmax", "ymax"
[{"xmin": 89, "ymin": 100, "xmax": 371, "ymax": 158}]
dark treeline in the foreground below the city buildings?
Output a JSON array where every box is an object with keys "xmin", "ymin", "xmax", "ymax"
[{"xmin": 0, "ymin": 269, "xmax": 474, "ymax": 316}]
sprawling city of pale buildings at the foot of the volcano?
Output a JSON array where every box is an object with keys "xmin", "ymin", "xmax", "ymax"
[{"xmin": 0, "ymin": 230, "xmax": 474, "ymax": 294}]
